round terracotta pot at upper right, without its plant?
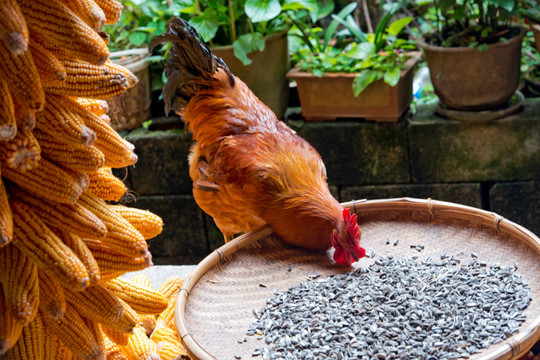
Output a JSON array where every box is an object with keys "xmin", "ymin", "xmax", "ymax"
[{"xmin": 418, "ymin": 27, "xmax": 525, "ymax": 111}]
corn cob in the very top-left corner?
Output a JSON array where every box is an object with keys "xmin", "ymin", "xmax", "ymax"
[{"xmin": 0, "ymin": 0, "xmax": 29, "ymax": 55}]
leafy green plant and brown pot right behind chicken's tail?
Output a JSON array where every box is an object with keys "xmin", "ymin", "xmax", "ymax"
[{"xmin": 173, "ymin": 0, "xmax": 308, "ymax": 118}]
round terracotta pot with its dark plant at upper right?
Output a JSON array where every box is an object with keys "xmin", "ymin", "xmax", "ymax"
[{"xmin": 418, "ymin": 0, "xmax": 525, "ymax": 114}]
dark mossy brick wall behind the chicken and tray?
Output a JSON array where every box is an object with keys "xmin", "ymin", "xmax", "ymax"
[{"xmin": 117, "ymin": 99, "xmax": 540, "ymax": 264}]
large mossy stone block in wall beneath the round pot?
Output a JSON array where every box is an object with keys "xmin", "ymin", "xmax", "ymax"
[{"xmin": 408, "ymin": 101, "xmax": 540, "ymax": 183}]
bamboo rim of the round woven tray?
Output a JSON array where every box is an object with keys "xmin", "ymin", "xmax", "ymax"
[{"xmin": 175, "ymin": 197, "xmax": 540, "ymax": 360}]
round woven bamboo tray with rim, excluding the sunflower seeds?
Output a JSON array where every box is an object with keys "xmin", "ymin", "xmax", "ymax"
[{"xmin": 176, "ymin": 198, "xmax": 540, "ymax": 360}]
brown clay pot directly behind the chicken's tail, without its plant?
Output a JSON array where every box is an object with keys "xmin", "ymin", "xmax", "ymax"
[{"xmin": 211, "ymin": 32, "xmax": 291, "ymax": 119}]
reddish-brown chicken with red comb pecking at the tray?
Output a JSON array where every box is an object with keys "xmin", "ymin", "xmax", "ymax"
[{"xmin": 151, "ymin": 19, "xmax": 365, "ymax": 265}]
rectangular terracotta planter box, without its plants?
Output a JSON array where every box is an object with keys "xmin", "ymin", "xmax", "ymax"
[{"xmin": 287, "ymin": 52, "xmax": 421, "ymax": 122}]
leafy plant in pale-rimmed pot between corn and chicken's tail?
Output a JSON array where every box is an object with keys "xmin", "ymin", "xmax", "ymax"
[{"xmin": 103, "ymin": 0, "xmax": 177, "ymax": 131}]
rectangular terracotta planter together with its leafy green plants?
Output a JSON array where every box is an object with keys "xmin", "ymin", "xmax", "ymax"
[{"xmin": 287, "ymin": 3, "xmax": 420, "ymax": 121}]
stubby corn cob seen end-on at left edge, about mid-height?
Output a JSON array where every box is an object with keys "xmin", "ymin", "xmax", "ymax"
[{"xmin": 0, "ymin": 129, "xmax": 41, "ymax": 172}]
